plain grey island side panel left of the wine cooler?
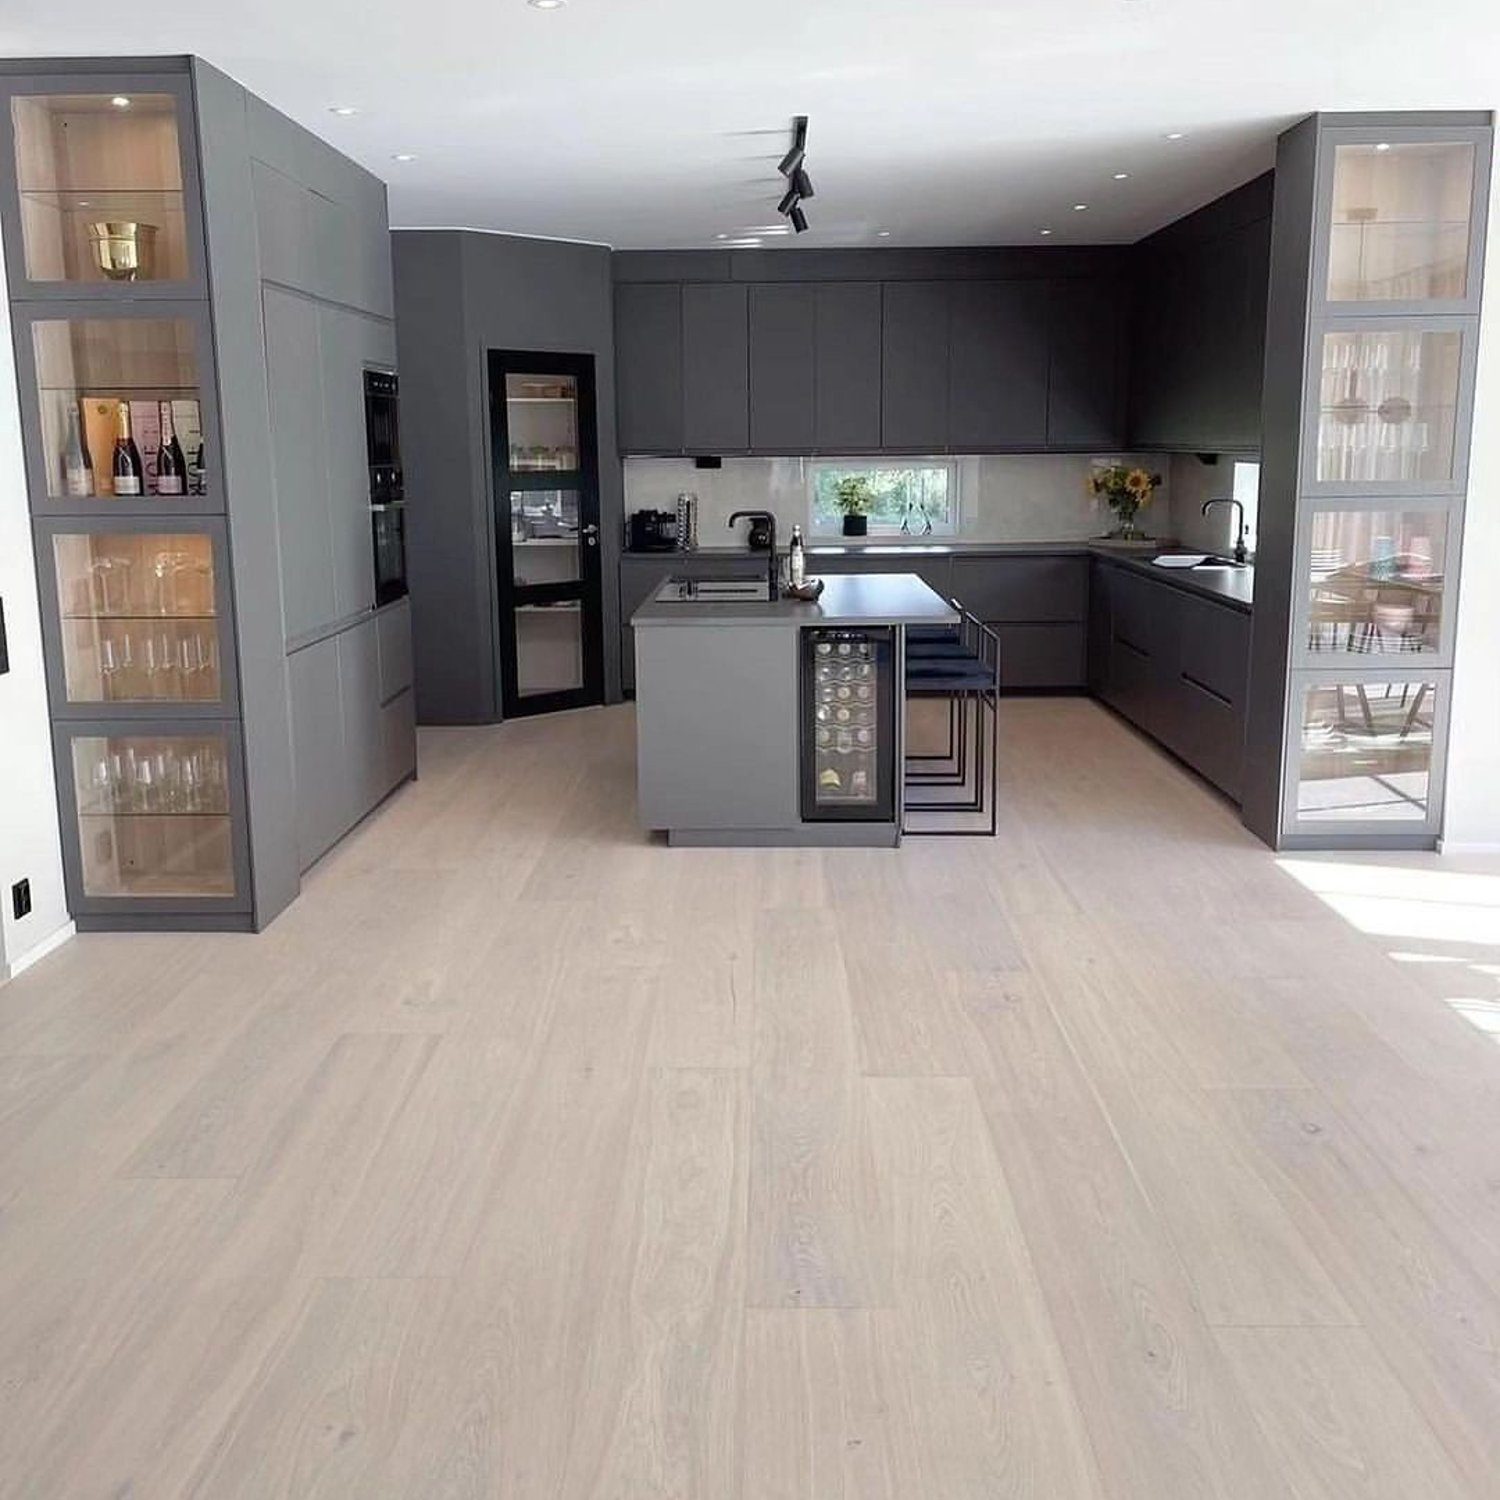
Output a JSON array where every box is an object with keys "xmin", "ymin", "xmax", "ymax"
[{"xmin": 635, "ymin": 623, "xmax": 801, "ymax": 830}]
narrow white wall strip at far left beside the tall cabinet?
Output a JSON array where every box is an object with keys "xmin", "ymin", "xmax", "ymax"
[{"xmin": 0, "ymin": 219, "xmax": 71, "ymax": 981}]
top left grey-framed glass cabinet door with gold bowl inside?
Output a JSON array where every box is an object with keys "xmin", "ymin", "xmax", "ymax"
[{"xmin": 3, "ymin": 74, "xmax": 204, "ymax": 299}]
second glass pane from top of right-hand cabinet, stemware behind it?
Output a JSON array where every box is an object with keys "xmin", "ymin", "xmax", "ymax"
[{"xmin": 1317, "ymin": 330, "xmax": 1464, "ymax": 485}]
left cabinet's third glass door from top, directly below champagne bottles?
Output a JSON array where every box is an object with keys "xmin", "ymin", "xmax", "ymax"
[{"xmin": 42, "ymin": 530, "xmax": 234, "ymax": 711}]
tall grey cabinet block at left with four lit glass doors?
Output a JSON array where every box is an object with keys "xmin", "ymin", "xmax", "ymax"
[{"xmin": 0, "ymin": 57, "xmax": 416, "ymax": 929}]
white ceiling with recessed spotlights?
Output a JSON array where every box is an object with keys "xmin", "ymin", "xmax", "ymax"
[{"xmin": 0, "ymin": 0, "xmax": 1500, "ymax": 248}]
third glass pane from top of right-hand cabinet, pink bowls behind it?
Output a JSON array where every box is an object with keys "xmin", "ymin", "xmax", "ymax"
[{"xmin": 1307, "ymin": 509, "xmax": 1448, "ymax": 656}]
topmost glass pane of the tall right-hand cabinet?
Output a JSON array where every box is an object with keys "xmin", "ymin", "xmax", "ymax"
[{"xmin": 1328, "ymin": 141, "xmax": 1475, "ymax": 302}]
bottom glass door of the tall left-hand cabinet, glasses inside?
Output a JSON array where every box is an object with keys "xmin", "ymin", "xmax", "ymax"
[{"xmin": 63, "ymin": 726, "xmax": 242, "ymax": 911}]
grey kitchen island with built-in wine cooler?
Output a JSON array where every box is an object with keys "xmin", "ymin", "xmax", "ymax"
[{"xmin": 630, "ymin": 573, "xmax": 959, "ymax": 848}]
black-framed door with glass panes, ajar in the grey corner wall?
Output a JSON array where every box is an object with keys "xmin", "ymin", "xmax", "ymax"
[{"xmin": 489, "ymin": 350, "xmax": 605, "ymax": 719}]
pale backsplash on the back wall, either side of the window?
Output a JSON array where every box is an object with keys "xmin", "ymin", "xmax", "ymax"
[{"xmin": 624, "ymin": 453, "xmax": 1172, "ymax": 546}]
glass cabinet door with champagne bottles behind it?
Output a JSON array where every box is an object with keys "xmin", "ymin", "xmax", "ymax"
[{"xmin": 29, "ymin": 317, "xmax": 212, "ymax": 510}]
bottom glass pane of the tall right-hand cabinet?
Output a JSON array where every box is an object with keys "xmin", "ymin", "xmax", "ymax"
[{"xmin": 1296, "ymin": 681, "xmax": 1437, "ymax": 824}]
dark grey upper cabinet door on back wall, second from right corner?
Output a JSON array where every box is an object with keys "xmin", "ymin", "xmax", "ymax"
[{"xmin": 947, "ymin": 281, "xmax": 1049, "ymax": 453}]
